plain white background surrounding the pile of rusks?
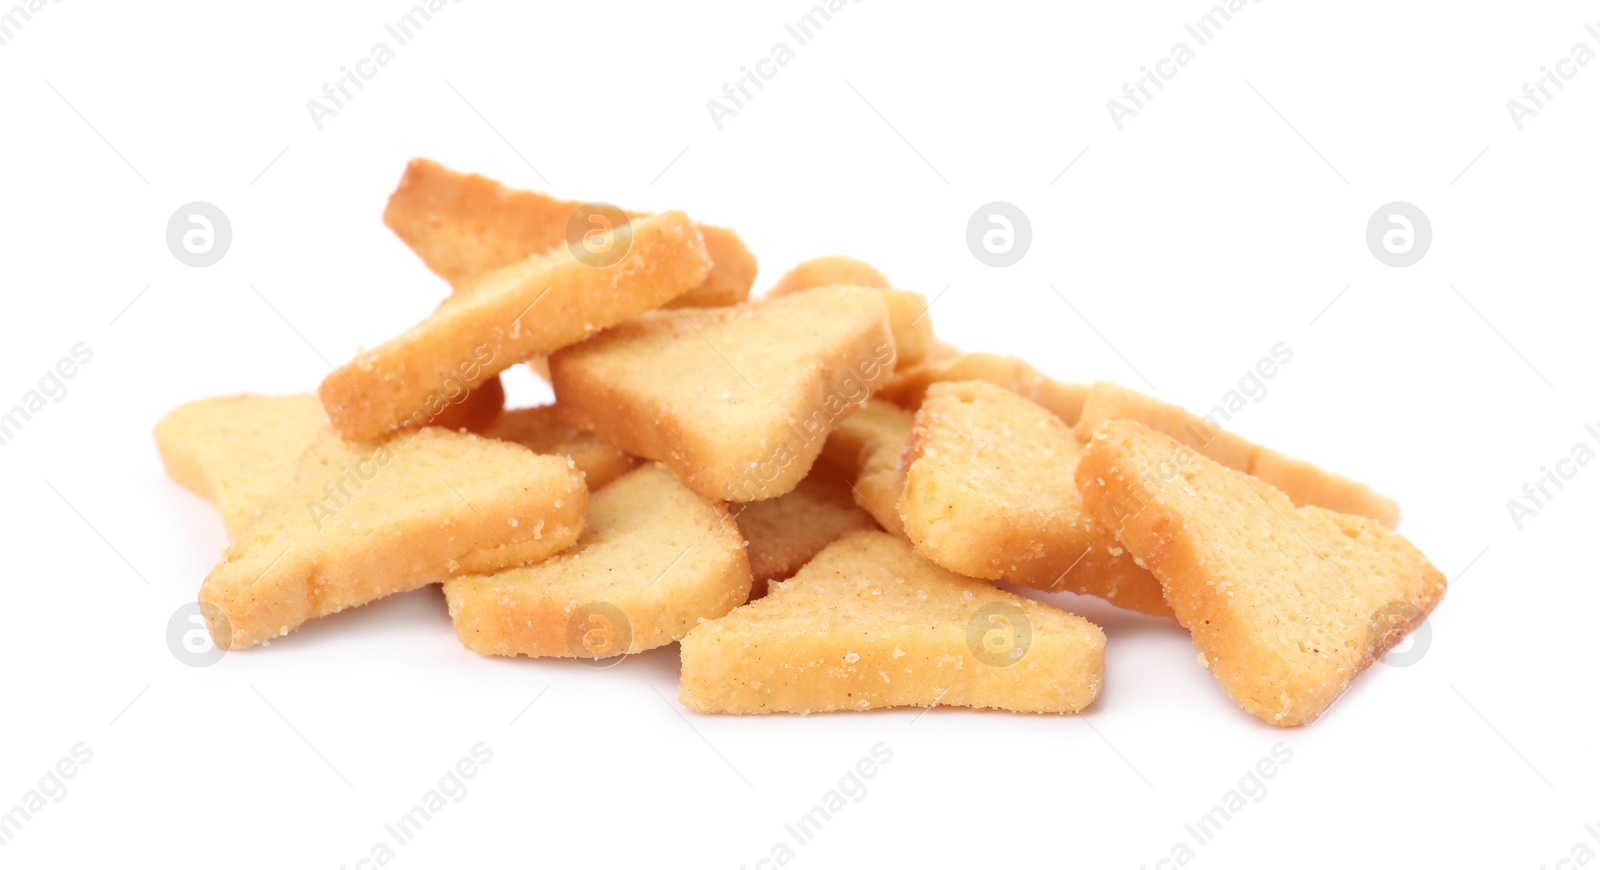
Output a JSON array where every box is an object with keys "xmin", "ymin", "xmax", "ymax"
[{"xmin": 0, "ymin": 0, "xmax": 1600, "ymax": 868}]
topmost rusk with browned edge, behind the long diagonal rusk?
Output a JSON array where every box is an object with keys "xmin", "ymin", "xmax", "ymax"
[{"xmin": 384, "ymin": 158, "xmax": 755, "ymax": 307}]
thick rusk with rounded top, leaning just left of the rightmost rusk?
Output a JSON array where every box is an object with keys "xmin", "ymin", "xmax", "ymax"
[{"xmin": 899, "ymin": 381, "xmax": 1171, "ymax": 616}]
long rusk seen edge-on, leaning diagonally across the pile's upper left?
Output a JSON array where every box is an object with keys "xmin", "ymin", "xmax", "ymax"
[{"xmin": 320, "ymin": 211, "xmax": 710, "ymax": 441}]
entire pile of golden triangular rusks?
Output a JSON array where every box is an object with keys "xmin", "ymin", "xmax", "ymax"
[{"xmin": 155, "ymin": 160, "xmax": 1445, "ymax": 726}]
